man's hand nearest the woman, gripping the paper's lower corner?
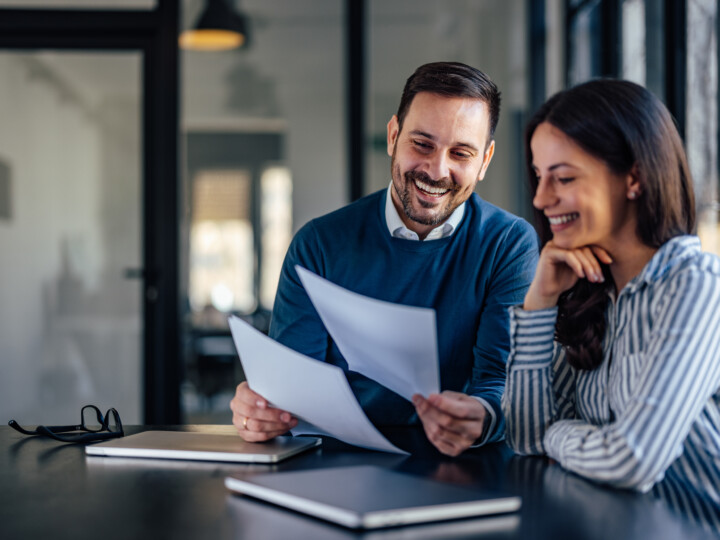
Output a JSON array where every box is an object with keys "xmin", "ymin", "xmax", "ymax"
[{"xmin": 413, "ymin": 390, "xmax": 490, "ymax": 456}]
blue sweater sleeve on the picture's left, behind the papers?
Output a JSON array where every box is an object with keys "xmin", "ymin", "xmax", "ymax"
[{"xmin": 269, "ymin": 222, "xmax": 329, "ymax": 361}]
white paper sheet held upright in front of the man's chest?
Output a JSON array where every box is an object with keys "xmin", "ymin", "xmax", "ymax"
[{"xmin": 295, "ymin": 265, "xmax": 440, "ymax": 400}]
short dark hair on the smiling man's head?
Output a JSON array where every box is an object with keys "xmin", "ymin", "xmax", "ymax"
[{"xmin": 397, "ymin": 62, "xmax": 500, "ymax": 144}]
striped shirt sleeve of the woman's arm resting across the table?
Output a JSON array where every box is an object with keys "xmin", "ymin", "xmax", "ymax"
[{"xmin": 543, "ymin": 269, "xmax": 720, "ymax": 491}]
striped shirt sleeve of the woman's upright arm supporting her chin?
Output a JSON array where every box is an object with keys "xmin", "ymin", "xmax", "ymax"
[{"xmin": 502, "ymin": 306, "xmax": 575, "ymax": 455}]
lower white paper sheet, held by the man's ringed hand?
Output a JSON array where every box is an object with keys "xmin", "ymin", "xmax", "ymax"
[{"xmin": 229, "ymin": 317, "xmax": 407, "ymax": 454}]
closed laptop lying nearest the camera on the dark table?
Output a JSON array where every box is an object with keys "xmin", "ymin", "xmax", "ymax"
[{"xmin": 225, "ymin": 465, "xmax": 521, "ymax": 529}]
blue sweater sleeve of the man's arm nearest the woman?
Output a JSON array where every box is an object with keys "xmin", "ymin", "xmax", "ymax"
[{"xmin": 466, "ymin": 220, "xmax": 538, "ymax": 444}]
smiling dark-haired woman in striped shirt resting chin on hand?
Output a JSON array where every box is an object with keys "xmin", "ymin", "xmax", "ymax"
[{"xmin": 503, "ymin": 80, "xmax": 720, "ymax": 500}]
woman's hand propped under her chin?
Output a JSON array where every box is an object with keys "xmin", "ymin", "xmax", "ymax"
[{"xmin": 523, "ymin": 240, "xmax": 612, "ymax": 311}]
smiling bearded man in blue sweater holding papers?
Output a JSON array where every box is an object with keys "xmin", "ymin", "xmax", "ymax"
[{"xmin": 230, "ymin": 62, "xmax": 538, "ymax": 456}]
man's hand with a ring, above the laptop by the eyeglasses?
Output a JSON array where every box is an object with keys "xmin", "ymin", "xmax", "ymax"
[{"xmin": 230, "ymin": 381, "xmax": 297, "ymax": 442}]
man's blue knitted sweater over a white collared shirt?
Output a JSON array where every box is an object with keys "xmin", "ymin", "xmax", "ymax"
[{"xmin": 270, "ymin": 189, "xmax": 538, "ymax": 442}]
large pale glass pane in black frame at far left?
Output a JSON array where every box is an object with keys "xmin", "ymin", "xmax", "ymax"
[{"xmin": 0, "ymin": 51, "xmax": 143, "ymax": 424}]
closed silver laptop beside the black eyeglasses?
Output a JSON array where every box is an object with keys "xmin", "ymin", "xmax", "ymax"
[{"xmin": 85, "ymin": 431, "xmax": 322, "ymax": 463}]
